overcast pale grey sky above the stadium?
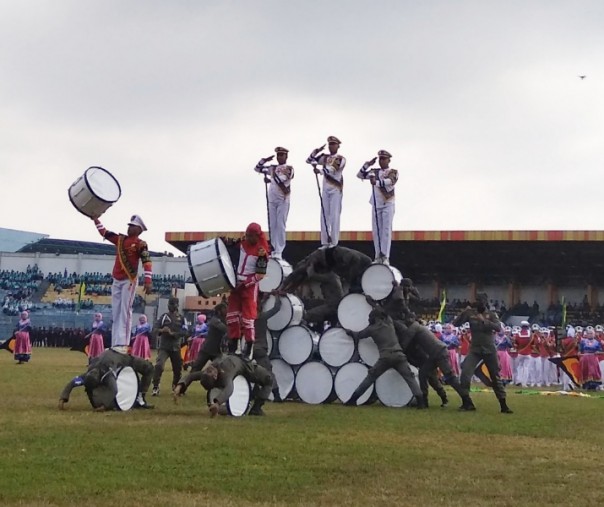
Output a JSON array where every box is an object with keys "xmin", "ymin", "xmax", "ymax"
[{"xmin": 0, "ymin": 0, "xmax": 604, "ymax": 251}]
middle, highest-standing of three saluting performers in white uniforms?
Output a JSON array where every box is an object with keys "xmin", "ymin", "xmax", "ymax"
[{"xmin": 306, "ymin": 136, "xmax": 346, "ymax": 247}]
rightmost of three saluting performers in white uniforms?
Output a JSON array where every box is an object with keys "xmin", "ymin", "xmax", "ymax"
[{"xmin": 357, "ymin": 150, "xmax": 398, "ymax": 264}]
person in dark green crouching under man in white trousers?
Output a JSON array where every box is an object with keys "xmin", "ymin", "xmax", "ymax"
[{"xmin": 59, "ymin": 349, "xmax": 153, "ymax": 412}]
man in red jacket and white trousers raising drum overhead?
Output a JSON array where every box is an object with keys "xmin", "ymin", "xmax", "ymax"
[{"xmin": 93, "ymin": 215, "xmax": 151, "ymax": 354}]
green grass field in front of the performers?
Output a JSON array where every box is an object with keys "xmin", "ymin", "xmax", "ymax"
[{"xmin": 0, "ymin": 349, "xmax": 604, "ymax": 507}]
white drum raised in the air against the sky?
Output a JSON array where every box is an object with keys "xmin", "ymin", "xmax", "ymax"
[{"xmin": 67, "ymin": 167, "xmax": 122, "ymax": 218}]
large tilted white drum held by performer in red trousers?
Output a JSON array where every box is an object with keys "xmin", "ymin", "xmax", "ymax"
[{"xmin": 187, "ymin": 238, "xmax": 237, "ymax": 298}]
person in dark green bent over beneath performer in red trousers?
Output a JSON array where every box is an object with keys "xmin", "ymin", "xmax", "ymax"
[{"xmin": 200, "ymin": 355, "xmax": 273, "ymax": 417}]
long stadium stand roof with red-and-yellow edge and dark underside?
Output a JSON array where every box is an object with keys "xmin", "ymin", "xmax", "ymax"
[{"xmin": 165, "ymin": 231, "xmax": 604, "ymax": 285}]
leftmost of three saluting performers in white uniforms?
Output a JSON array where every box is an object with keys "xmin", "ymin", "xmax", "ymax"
[{"xmin": 255, "ymin": 146, "xmax": 294, "ymax": 259}]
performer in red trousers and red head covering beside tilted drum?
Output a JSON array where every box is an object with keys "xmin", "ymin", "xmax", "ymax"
[{"xmin": 227, "ymin": 223, "xmax": 270, "ymax": 358}]
